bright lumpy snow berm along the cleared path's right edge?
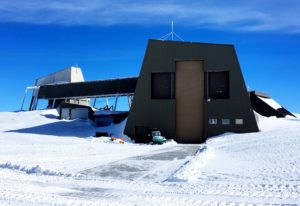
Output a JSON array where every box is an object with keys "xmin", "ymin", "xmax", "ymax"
[{"xmin": 168, "ymin": 144, "xmax": 214, "ymax": 182}]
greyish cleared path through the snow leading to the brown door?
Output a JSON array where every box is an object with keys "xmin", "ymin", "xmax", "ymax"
[{"xmin": 80, "ymin": 144, "xmax": 199, "ymax": 182}]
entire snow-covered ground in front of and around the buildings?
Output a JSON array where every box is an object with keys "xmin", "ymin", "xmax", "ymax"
[{"xmin": 0, "ymin": 110, "xmax": 300, "ymax": 205}]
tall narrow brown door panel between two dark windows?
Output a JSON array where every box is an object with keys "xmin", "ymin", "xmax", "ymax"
[{"xmin": 175, "ymin": 61, "xmax": 204, "ymax": 143}]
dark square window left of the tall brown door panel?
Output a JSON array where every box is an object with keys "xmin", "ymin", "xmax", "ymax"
[{"xmin": 151, "ymin": 72, "xmax": 175, "ymax": 99}]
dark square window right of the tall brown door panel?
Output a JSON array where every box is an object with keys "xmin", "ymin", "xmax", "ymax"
[{"xmin": 205, "ymin": 72, "xmax": 229, "ymax": 99}]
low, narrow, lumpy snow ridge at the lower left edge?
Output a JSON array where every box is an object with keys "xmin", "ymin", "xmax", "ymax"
[{"xmin": 0, "ymin": 162, "xmax": 78, "ymax": 177}]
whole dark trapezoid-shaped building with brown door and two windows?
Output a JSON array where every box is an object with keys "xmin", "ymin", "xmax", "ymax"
[{"xmin": 124, "ymin": 40, "xmax": 258, "ymax": 143}]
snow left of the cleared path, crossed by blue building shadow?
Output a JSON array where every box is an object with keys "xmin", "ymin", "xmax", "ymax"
[{"xmin": 0, "ymin": 110, "xmax": 171, "ymax": 174}]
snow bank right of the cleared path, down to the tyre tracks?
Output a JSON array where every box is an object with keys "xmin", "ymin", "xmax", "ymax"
[{"xmin": 171, "ymin": 114, "xmax": 300, "ymax": 188}]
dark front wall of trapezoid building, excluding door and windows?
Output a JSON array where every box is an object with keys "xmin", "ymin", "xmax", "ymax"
[{"xmin": 125, "ymin": 40, "xmax": 258, "ymax": 142}]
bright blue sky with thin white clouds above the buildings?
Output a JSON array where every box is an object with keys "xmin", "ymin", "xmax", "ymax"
[{"xmin": 0, "ymin": 0, "xmax": 300, "ymax": 113}]
